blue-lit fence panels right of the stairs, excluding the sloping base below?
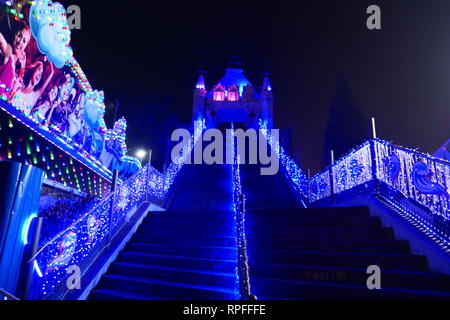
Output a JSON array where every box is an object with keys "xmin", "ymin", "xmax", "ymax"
[{"xmin": 309, "ymin": 139, "xmax": 450, "ymax": 219}]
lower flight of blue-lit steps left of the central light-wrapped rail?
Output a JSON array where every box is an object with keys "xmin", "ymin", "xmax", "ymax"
[{"xmin": 90, "ymin": 212, "xmax": 237, "ymax": 300}]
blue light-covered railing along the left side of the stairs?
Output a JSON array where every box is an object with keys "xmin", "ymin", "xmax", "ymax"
[{"xmin": 29, "ymin": 126, "xmax": 204, "ymax": 299}]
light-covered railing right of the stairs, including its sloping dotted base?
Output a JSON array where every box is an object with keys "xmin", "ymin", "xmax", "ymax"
[{"xmin": 309, "ymin": 139, "xmax": 450, "ymax": 250}]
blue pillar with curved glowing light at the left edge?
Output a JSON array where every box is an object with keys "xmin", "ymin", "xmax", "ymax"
[{"xmin": 0, "ymin": 161, "xmax": 44, "ymax": 295}]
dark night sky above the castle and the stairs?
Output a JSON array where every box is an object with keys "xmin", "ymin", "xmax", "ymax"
[{"xmin": 61, "ymin": 0, "xmax": 450, "ymax": 171}]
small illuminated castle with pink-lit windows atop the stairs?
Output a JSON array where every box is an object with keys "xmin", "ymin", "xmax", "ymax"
[{"xmin": 192, "ymin": 57, "xmax": 273, "ymax": 128}]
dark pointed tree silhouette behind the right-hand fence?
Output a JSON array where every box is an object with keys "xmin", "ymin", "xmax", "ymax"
[{"xmin": 324, "ymin": 75, "xmax": 369, "ymax": 165}]
